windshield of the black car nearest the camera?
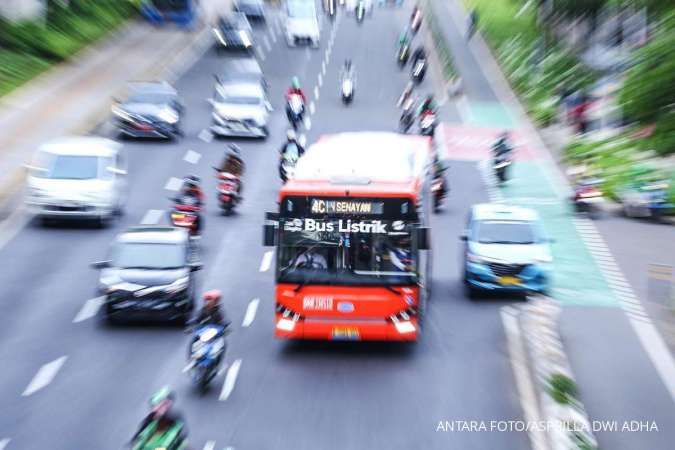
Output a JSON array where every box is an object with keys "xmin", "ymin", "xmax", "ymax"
[{"xmin": 112, "ymin": 242, "xmax": 186, "ymax": 269}]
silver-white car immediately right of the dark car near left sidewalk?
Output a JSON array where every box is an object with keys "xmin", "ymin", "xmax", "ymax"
[{"xmin": 211, "ymin": 80, "xmax": 272, "ymax": 139}]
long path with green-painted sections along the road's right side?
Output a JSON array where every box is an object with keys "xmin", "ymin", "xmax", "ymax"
[{"xmin": 431, "ymin": 0, "xmax": 675, "ymax": 450}]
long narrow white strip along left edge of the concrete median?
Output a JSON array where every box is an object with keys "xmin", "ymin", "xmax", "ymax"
[{"xmin": 500, "ymin": 306, "xmax": 548, "ymax": 450}]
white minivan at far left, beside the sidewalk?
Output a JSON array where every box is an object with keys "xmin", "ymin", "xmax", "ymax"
[{"xmin": 26, "ymin": 137, "xmax": 127, "ymax": 224}]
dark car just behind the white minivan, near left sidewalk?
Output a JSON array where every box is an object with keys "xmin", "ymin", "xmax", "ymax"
[{"xmin": 112, "ymin": 81, "xmax": 183, "ymax": 139}]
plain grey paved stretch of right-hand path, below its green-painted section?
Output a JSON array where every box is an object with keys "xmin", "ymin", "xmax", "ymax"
[{"xmin": 560, "ymin": 307, "xmax": 675, "ymax": 450}]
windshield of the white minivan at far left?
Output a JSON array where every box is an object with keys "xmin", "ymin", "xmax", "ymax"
[{"xmin": 32, "ymin": 153, "xmax": 112, "ymax": 180}]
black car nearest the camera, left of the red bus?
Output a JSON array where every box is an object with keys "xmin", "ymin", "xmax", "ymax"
[{"xmin": 92, "ymin": 227, "xmax": 201, "ymax": 323}]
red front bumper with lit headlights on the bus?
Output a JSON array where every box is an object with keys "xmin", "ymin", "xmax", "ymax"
[{"xmin": 274, "ymin": 314, "xmax": 420, "ymax": 341}]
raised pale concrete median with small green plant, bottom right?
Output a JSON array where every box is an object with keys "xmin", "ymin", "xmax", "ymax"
[{"xmin": 502, "ymin": 296, "xmax": 598, "ymax": 450}]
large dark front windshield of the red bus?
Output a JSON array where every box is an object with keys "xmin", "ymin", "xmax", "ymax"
[{"xmin": 277, "ymin": 219, "xmax": 417, "ymax": 285}]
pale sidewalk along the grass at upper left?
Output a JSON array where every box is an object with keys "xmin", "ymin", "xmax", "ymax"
[{"xmin": 0, "ymin": 5, "xmax": 230, "ymax": 209}]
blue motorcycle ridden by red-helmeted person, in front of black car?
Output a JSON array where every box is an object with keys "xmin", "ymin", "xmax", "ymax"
[{"xmin": 183, "ymin": 324, "xmax": 227, "ymax": 392}]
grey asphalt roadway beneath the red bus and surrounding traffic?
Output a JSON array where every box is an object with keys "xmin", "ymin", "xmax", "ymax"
[{"xmin": 0, "ymin": 9, "xmax": 528, "ymax": 450}]
